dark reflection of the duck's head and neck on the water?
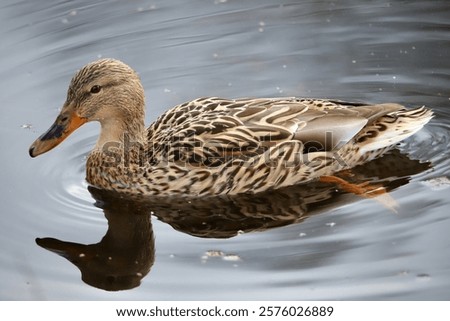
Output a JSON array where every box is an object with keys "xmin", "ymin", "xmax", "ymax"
[{"xmin": 36, "ymin": 188, "xmax": 155, "ymax": 291}]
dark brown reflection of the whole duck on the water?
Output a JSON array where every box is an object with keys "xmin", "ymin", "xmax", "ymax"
[{"xmin": 36, "ymin": 150, "xmax": 430, "ymax": 291}]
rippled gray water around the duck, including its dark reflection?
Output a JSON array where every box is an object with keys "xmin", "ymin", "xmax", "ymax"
[{"xmin": 0, "ymin": 0, "xmax": 450, "ymax": 300}]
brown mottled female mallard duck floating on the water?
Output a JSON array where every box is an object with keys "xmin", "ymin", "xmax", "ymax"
[{"xmin": 30, "ymin": 59, "xmax": 433, "ymax": 195}]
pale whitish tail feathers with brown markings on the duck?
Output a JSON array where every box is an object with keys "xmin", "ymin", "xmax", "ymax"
[{"xmin": 355, "ymin": 106, "xmax": 433, "ymax": 154}]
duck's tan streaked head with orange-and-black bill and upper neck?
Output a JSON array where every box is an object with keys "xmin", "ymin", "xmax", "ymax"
[{"xmin": 29, "ymin": 59, "xmax": 145, "ymax": 157}]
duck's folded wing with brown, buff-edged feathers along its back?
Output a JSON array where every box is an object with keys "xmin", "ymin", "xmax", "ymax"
[{"xmin": 148, "ymin": 97, "xmax": 402, "ymax": 166}]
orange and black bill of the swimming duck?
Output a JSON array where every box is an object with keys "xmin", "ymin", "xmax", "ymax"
[{"xmin": 29, "ymin": 112, "xmax": 87, "ymax": 157}]
